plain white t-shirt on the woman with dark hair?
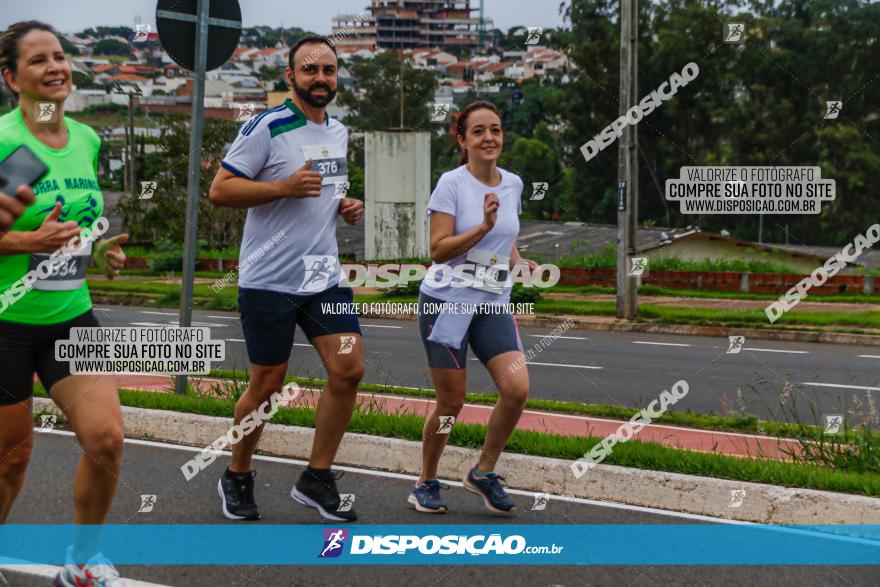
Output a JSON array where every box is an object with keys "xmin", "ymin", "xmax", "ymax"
[{"xmin": 420, "ymin": 165, "xmax": 523, "ymax": 304}]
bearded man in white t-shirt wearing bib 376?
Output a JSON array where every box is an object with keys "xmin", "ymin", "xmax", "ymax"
[{"xmin": 211, "ymin": 37, "xmax": 364, "ymax": 521}]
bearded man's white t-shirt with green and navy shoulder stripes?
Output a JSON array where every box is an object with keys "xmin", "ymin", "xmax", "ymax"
[{"xmin": 222, "ymin": 99, "xmax": 348, "ymax": 295}]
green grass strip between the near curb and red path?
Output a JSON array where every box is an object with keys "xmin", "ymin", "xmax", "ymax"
[{"xmin": 31, "ymin": 389, "xmax": 880, "ymax": 496}]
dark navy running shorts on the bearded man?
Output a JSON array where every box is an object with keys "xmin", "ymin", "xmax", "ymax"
[{"xmin": 238, "ymin": 285, "xmax": 361, "ymax": 366}]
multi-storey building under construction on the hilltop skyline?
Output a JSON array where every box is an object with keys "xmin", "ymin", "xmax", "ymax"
[{"xmin": 333, "ymin": 0, "xmax": 493, "ymax": 52}]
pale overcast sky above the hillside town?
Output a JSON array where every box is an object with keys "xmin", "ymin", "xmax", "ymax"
[{"xmin": 0, "ymin": 0, "xmax": 562, "ymax": 34}]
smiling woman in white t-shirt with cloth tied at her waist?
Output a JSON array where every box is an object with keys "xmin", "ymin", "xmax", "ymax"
[{"xmin": 407, "ymin": 102, "xmax": 535, "ymax": 514}]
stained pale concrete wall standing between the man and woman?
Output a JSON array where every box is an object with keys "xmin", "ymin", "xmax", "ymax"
[{"xmin": 364, "ymin": 131, "xmax": 431, "ymax": 260}]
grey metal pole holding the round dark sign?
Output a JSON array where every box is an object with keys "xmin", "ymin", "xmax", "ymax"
[{"xmin": 175, "ymin": 0, "xmax": 211, "ymax": 394}]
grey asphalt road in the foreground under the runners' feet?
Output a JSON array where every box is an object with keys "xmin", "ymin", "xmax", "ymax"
[{"xmin": 4, "ymin": 431, "xmax": 880, "ymax": 587}]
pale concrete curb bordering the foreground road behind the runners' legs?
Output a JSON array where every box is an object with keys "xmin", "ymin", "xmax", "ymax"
[{"xmin": 34, "ymin": 398, "xmax": 880, "ymax": 524}]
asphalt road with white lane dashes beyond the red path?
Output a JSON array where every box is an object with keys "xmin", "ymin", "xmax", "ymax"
[{"xmin": 96, "ymin": 306, "xmax": 880, "ymax": 425}]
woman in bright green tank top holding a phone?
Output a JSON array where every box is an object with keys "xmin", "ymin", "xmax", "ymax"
[{"xmin": 0, "ymin": 21, "xmax": 128, "ymax": 587}]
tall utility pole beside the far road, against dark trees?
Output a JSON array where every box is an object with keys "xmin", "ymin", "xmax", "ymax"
[{"xmin": 617, "ymin": 0, "xmax": 639, "ymax": 320}]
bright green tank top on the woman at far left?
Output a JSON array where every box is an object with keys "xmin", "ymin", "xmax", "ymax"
[{"xmin": 0, "ymin": 108, "xmax": 104, "ymax": 324}]
